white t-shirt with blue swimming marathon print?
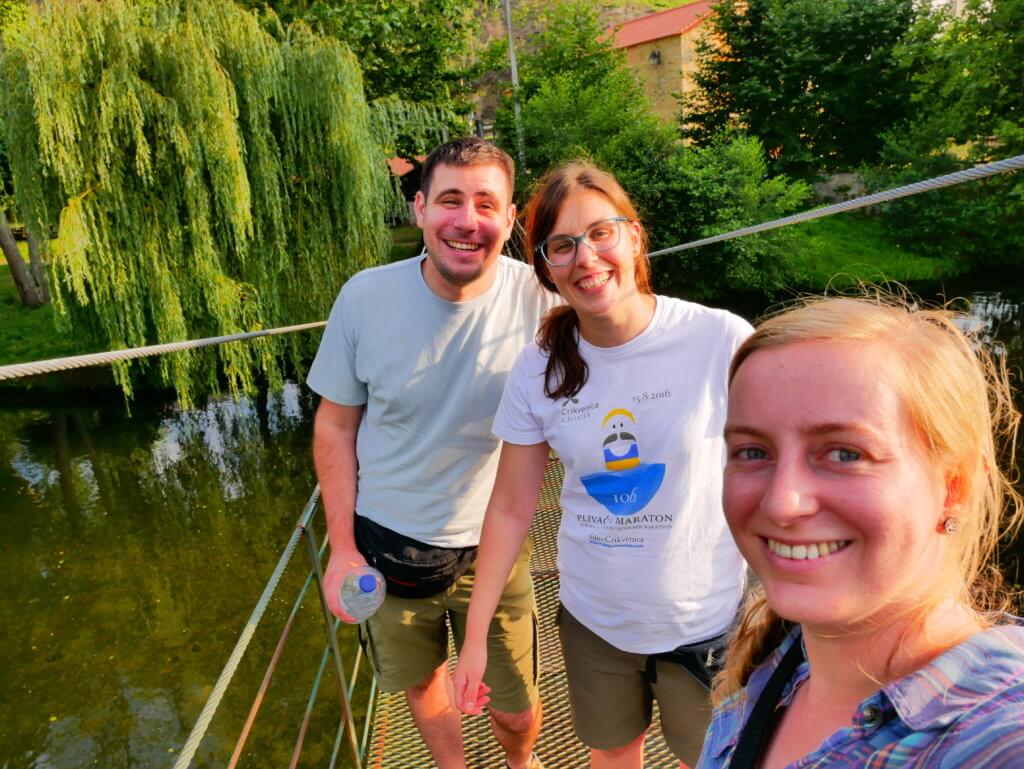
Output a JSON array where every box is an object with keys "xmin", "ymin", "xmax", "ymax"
[{"xmin": 494, "ymin": 296, "xmax": 752, "ymax": 654}]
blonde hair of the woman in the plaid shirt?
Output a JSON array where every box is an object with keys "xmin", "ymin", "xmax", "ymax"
[{"xmin": 713, "ymin": 292, "xmax": 1024, "ymax": 703}]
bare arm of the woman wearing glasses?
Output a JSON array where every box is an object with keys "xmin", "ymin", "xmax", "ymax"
[{"xmin": 455, "ymin": 443, "xmax": 548, "ymax": 713}]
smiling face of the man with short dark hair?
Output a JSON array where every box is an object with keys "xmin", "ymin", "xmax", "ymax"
[{"xmin": 415, "ymin": 163, "xmax": 515, "ymax": 301}]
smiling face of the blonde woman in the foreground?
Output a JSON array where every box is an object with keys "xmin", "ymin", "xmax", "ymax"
[{"xmin": 723, "ymin": 341, "xmax": 948, "ymax": 630}]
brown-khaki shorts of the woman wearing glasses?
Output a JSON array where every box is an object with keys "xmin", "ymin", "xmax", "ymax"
[{"xmin": 558, "ymin": 606, "xmax": 712, "ymax": 766}]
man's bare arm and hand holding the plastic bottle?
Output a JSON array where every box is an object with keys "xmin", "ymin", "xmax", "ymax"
[{"xmin": 313, "ymin": 398, "xmax": 367, "ymax": 622}]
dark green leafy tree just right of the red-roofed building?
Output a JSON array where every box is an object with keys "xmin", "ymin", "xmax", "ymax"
[{"xmin": 685, "ymin": 0, "xmax": 913, "ymax": 174}]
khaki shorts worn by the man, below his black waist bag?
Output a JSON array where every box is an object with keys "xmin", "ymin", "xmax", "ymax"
[{"xmin": 359, "ymin": 541, "xmax": 541, "ymax": 713}]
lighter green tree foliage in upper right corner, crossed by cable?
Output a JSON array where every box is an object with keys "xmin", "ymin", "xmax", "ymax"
[{"xmin": 867, "ymin": 0, "xmax": 1024, "ymax": 268}]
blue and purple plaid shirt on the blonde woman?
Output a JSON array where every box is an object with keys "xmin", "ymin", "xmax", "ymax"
[{"xmin": 697, "ymin": 617, "xmax": 1024, "ymax": 769}]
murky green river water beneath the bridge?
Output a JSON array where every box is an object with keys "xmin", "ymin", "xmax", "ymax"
[{"xmin": 0, "ymin": 283, "xmax": 1024, "ymax": 769}]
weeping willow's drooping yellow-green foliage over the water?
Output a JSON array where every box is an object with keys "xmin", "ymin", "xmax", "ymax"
[{"xmin": 0, "ymin": 0, "xmax": 393, "ymax": 403}]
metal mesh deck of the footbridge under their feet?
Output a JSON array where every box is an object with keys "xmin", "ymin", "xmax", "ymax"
[{"xmin": 365, "ymin": 459, "xmax": 679, "ymax": 769}]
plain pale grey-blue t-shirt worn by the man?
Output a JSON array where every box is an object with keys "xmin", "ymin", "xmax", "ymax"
[{"xmin": 307, "ymin": 255, "xmax": 560, "ymax": 547}]
